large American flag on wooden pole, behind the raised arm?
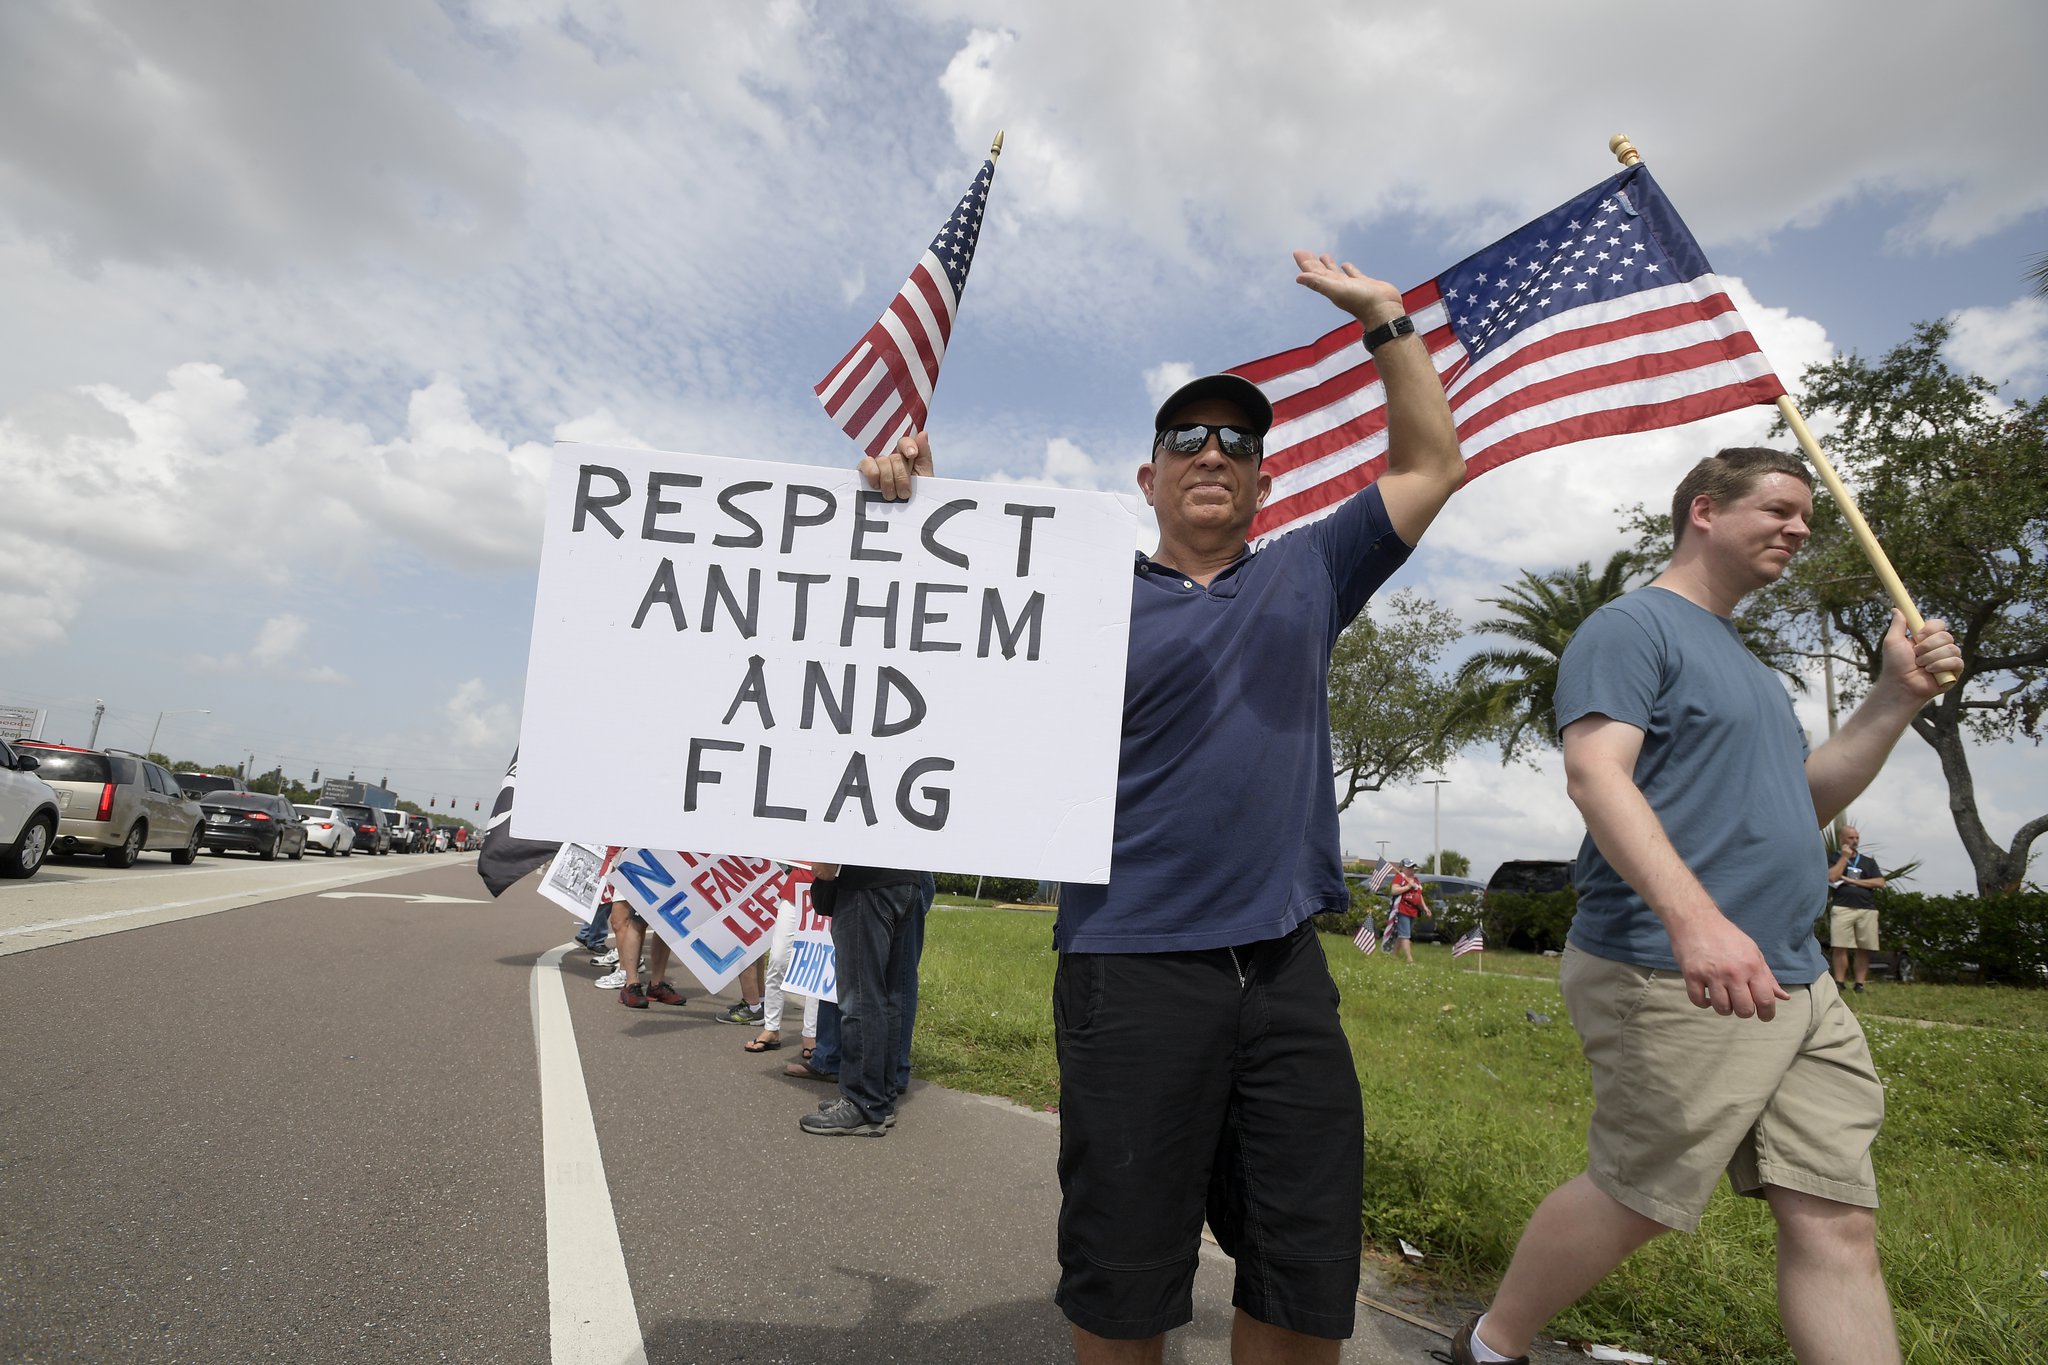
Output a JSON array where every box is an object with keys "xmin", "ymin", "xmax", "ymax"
[{"xmin": 1233, "ymin": 166, "xmax": 1784, "ymax": 540}]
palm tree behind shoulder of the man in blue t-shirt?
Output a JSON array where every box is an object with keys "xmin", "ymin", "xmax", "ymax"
[{"xmin": 1452, "ymin": 551, "xmax": 1651, "ymax": 765}]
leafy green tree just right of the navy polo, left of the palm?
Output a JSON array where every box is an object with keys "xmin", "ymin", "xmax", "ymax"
[{"xmin": 1329, "ymin": 591, "xmax": 1479, "ymax": 810}]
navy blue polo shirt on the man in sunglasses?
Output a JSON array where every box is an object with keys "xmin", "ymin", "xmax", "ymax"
[{"xmin": 1053, "ymin": 487, "xmax": 1409, "ymax": 954}]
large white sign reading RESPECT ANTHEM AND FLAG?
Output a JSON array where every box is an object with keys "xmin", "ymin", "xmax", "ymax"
[{"xmin": 512, "ymin": 444, "xmax": 1135, "ymax": 882}]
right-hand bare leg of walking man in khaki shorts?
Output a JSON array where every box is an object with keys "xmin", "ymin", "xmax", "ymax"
[{"xmin": 1763, "ymin": 1185, "xmax": 1898, "ymax": 1365}]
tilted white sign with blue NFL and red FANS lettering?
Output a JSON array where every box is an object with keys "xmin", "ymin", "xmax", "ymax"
[{"xmin": 606, "ymin": 843, "xmax": 782, "ymax": 990}]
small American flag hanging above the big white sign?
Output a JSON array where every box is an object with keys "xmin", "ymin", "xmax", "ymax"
[{"xmin": 817, "ymin": 156, "xmax": 995, "ymax": 456}]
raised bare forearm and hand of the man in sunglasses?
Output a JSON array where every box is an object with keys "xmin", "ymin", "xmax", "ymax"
[{"xmin": 1294, "ymin": 252, "xmax": 1464, "ymax": 546}]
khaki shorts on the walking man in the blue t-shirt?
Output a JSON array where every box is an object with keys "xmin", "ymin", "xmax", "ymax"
[{"xmin": 1559, "ymin": 945, "xmax": 1884, "ymax": 1232}]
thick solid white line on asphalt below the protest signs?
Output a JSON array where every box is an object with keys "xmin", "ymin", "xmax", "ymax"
[{"xmin": 528, "ymin": 943, "xmax": 647, "ymax": 1365}]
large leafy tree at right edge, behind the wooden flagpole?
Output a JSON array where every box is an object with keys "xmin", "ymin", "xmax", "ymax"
[{"xmin": 1751, "ymin": 321, "xmax": 2048, "ymax": 894}]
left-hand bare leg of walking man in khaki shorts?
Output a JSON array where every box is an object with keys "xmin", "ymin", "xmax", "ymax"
[{"xmin": 1485, "ymin": 1175, "xmax": 1669, "ymax": 1355}]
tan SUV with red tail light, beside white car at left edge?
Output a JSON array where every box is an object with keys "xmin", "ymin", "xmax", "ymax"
[{"xmin": 16, "ymin": 739, "xmax": 203, "ymax": 868}]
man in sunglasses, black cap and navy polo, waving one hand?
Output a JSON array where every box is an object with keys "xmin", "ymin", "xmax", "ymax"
[{"xmin": 860, "ymin": 252, "xmax": 1464, "ymax": 1365}]
